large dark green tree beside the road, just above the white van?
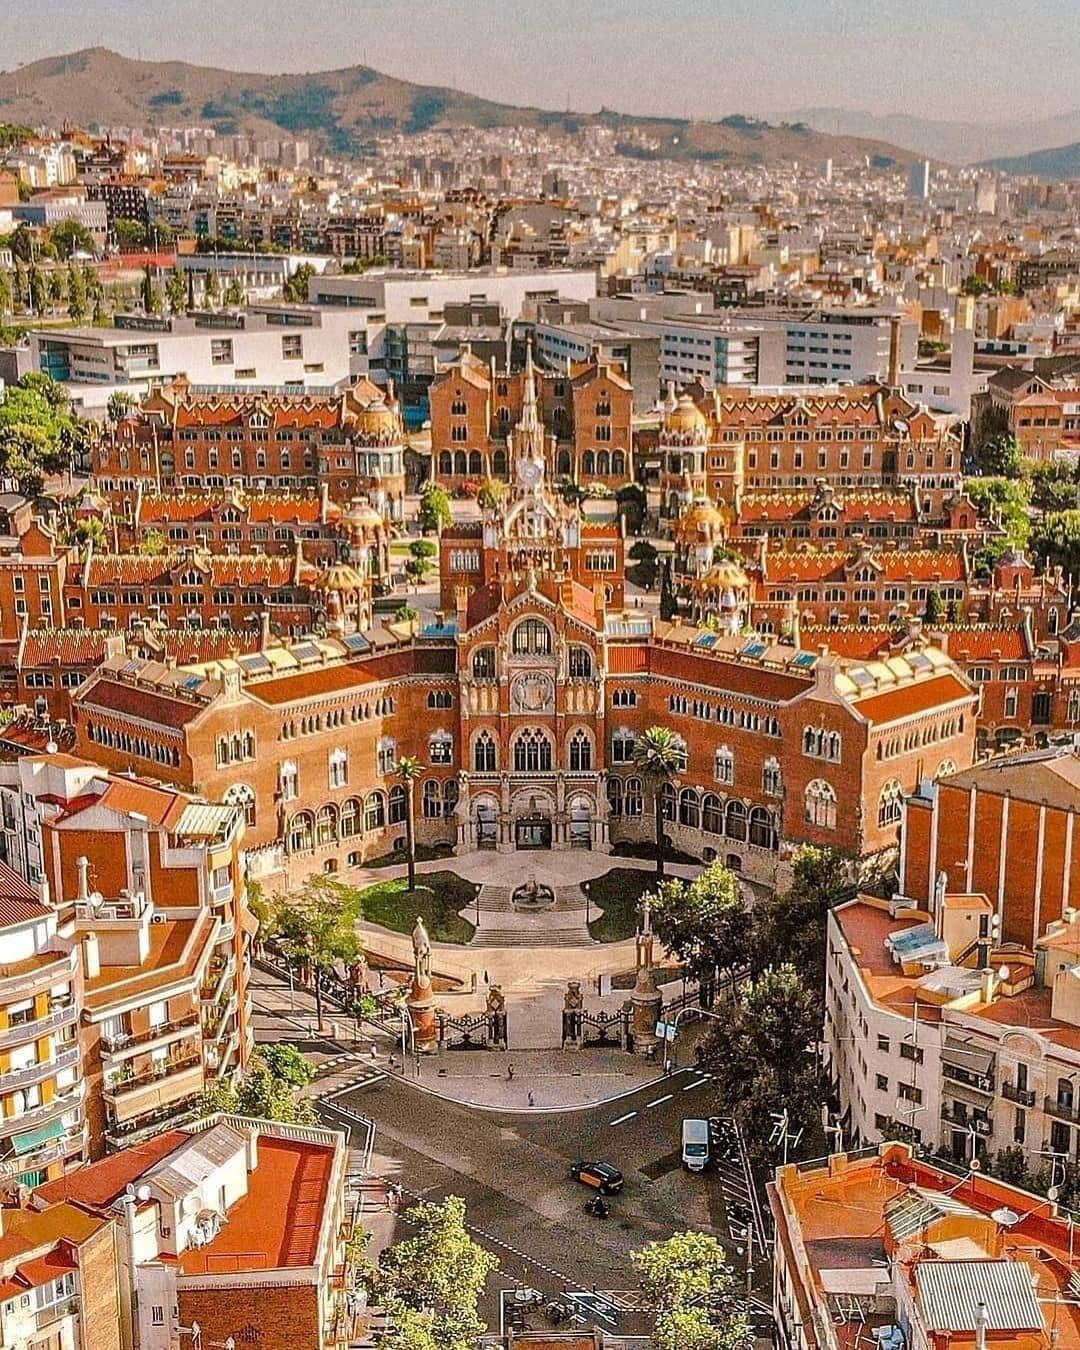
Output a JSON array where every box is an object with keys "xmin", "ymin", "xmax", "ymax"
[{"xmin": 699, "ymin": 964, "xmax": 821, "ymax": 1154}]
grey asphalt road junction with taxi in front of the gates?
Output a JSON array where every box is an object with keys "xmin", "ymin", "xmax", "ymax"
[{"xmin": 320, "ymin": 1064, "xmax": 768, "ymax": 1334}]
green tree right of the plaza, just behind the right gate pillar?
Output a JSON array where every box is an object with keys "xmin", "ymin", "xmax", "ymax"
[{"xmin": 648, "ymin": 863, "xmax": 753, "ymax": 981}]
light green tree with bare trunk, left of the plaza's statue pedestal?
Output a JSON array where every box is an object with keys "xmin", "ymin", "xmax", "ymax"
[{"xmin": 267, "ymin": 873, "xmax": 360, "ymax": 1031}]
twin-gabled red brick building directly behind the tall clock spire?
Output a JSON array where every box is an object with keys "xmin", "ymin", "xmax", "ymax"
[{"xmin": 429, "ymin": 348, "xmax": 633, "ymax": 489}]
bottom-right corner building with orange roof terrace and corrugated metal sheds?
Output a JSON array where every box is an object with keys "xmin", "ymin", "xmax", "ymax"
[{"xmin": 768, "ymin": 1142, "xmax": 1080, "ymax": 1350}]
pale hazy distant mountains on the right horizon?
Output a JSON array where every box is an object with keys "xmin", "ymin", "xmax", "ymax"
[{"xmin": 783, "ymin": 108, "xmax": 1080, "ymax": 173}]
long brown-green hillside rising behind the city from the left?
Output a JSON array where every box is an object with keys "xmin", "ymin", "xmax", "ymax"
[{"xmin": 0, "ymin": 47, "xmax": 914, "ymax": 167}]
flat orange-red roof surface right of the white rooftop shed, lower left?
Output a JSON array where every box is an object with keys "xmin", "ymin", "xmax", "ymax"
[{"xmin": 180, "ymin": 1135, "xmax": 333, "ymax": 1276}]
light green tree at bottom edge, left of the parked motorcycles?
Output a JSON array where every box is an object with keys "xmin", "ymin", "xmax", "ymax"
[{"xmin": 379, "ymin": 1195, "xmax": 498, "ymax": 1350}]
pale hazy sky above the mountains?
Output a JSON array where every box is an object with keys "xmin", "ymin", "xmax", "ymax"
[{"xmin": 0, "ymin": 0, "xmax": 1080, "ymax": 120}]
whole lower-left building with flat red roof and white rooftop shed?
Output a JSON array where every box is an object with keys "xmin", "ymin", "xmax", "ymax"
[{"xmin": 31, "ymin": 1115, "xmax": 353, "ymax": 1350}]
